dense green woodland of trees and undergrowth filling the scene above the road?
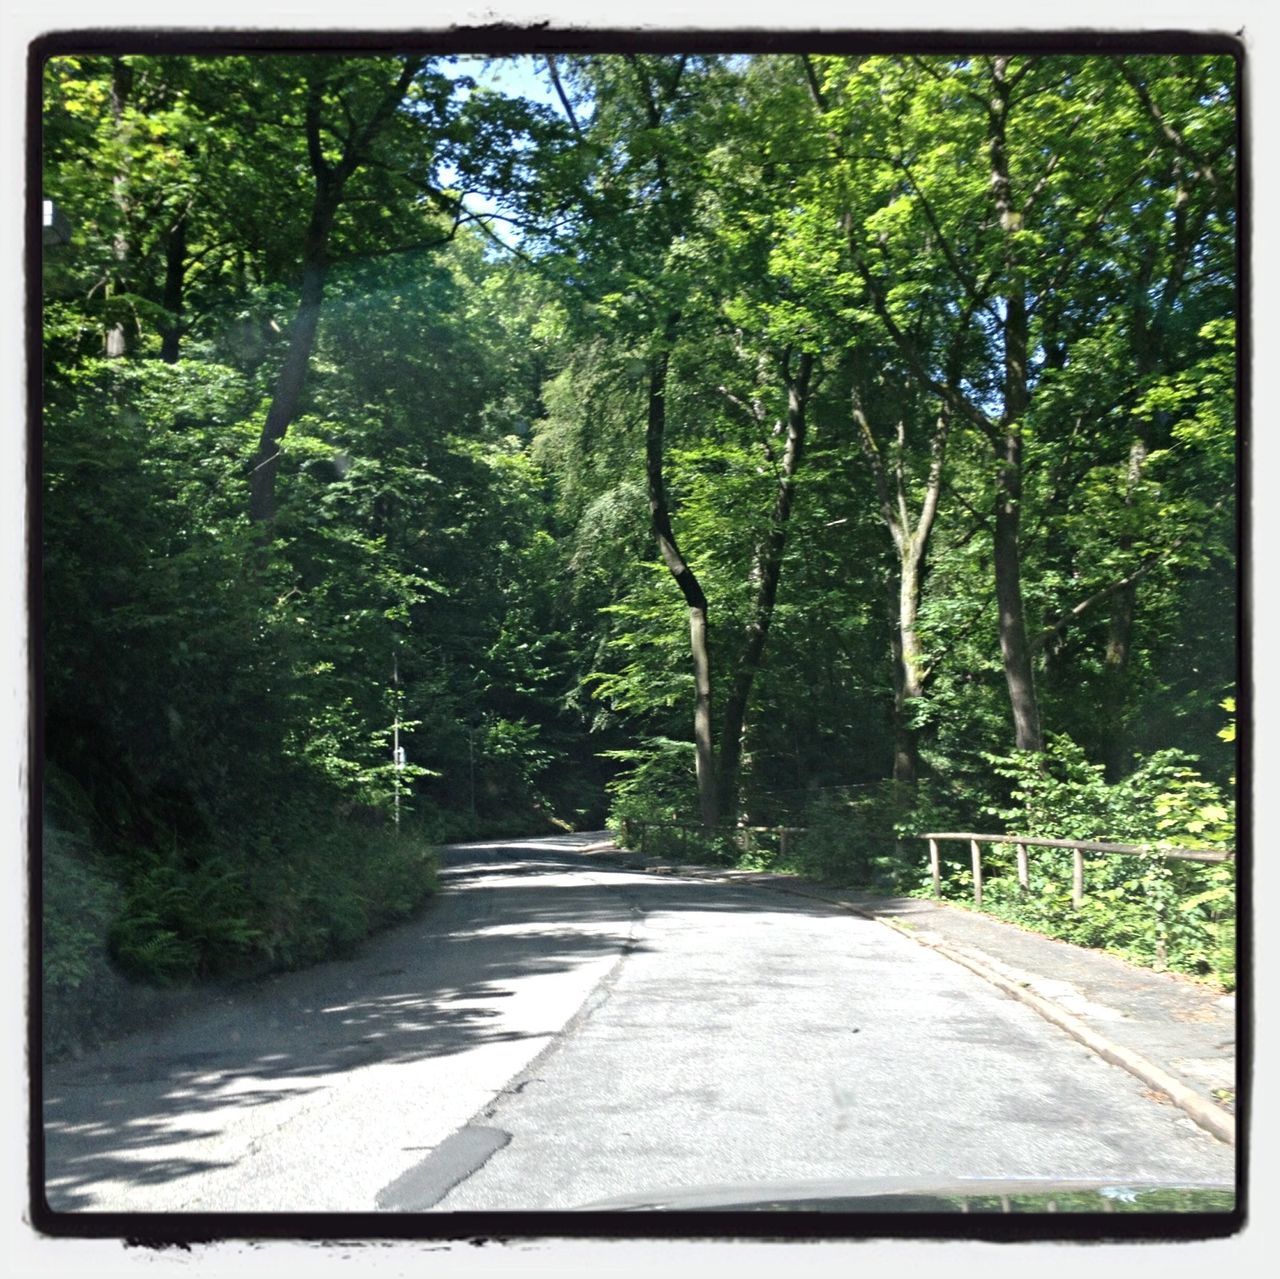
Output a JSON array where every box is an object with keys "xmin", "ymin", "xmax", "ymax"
[{"xmin": 42, "ymin": 45, "xmax": 1236, "ymax": 1054}]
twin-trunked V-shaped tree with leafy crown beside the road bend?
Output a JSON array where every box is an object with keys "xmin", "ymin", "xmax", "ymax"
[{"xmin": 542, "ymin": 55, "xmax": 819, "ymax": 827}]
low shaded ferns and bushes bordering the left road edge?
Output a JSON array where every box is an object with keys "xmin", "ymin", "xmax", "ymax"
[{"xmin": 42, "ymin": 769, "xmax": 436, "ymax": 1059}]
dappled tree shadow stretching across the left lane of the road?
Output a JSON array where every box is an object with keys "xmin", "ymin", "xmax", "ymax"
[{"xmin": 44, "ymin": 842, "xmax": 860, "ymax": 1212}]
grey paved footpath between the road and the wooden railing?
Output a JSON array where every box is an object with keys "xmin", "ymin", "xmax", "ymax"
[{"xmin": 598, "ymin": 848, "xmax": 1238, "ymax": 1141}]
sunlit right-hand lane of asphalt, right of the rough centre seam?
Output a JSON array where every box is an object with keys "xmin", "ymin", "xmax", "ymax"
[{"xmin": 439, "ymin": 858, "xmax": 1234, "ymax": 1211}]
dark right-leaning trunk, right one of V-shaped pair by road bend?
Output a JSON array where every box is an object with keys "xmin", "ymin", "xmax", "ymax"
[{"xmin": 718, "ymin": 353, "xmax": 813, "ymax": 819}]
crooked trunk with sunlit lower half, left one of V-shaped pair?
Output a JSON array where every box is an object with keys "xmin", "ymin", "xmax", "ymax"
[{"xmin": 645, "ymin": 314, "xmax": 719, "ymax": 827}]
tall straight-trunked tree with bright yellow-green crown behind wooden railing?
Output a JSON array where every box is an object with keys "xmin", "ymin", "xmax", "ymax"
[{"xmin": 812, "ymin": 56, "xmax": 1233, "ymax": 749}]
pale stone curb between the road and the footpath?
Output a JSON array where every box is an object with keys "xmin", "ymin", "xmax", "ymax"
[{"xmin": 614, "ymin": 845, "xmax": 1235, "ymax": 1146}]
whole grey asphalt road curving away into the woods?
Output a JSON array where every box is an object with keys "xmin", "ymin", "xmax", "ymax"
[{"xmin": 45, "ymin": 836, "xmax": 1233, "ymax": 1212}]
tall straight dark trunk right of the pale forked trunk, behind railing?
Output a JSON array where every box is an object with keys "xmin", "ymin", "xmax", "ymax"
[{"xmin": 988, "ymin": 58, "xmax": 1044, "ymax": 750}]
